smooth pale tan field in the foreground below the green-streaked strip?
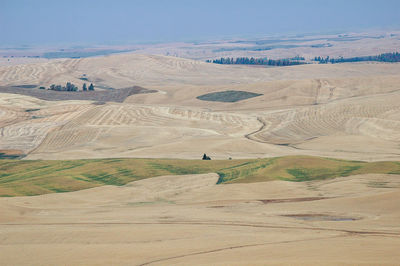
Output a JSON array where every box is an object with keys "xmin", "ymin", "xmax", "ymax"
[{"xmin": 0, "ymin": 174, "xmax": 400, "ymax": 265}]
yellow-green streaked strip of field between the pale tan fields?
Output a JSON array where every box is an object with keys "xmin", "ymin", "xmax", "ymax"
[{"xmin": 0, "ymin": 156, "xmax": 400, "ymax": 197}]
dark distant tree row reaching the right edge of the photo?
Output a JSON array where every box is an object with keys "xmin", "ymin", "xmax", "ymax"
[{"xmin": 314, "ymin": 52, "xmax": 400, "ymax": 64}]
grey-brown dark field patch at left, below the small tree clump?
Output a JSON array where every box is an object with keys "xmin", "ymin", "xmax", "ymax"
[{"xmin": 0, "ymin": 86, "xmax": 157, "ymax": 103}]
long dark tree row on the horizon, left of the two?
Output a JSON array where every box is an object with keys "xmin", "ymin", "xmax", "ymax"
[{"xmin": 206, "ymin": 57, "xmax": 306, "ymax": 66}]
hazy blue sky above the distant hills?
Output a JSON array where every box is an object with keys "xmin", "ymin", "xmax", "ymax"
[{"xmin": 0, "ymin": 0, "xmax": 400, "ymax": 45}]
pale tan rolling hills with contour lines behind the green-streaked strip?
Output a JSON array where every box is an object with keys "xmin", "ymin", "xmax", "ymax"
[{"xmin": 0, "ymin": 54, "xmax": 400, "ymax": 161}]
